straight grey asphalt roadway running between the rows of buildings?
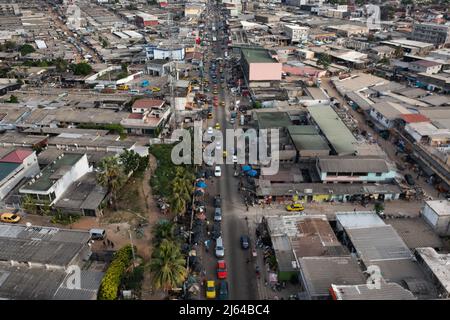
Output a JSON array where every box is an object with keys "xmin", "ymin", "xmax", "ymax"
[{"xmin": 203, "ymin": 5, "xmax": 258, "ymax": 300}]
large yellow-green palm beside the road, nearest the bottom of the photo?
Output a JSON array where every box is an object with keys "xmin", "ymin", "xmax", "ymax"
[{"xmin": 150, "ymin": 239, "xmax": 187, "ymax": 291}]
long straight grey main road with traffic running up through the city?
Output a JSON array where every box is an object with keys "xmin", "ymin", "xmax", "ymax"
[{"xmin": 204, "ymin": 6, "xmax": 259, "ymax": 300}]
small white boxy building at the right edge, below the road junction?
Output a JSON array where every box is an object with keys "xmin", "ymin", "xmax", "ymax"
[{"xmin": 421, "ymin": 200, "xmax": 450, "ymax": 236}]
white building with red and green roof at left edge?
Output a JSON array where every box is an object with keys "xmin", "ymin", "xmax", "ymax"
[{"xmin": 0, "ymin": 149, "xmax": 39, "ymax": 200}]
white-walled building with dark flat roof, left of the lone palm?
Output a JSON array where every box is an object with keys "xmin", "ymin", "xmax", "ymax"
[{"xmin": 19, "ymin": 153, "xmax": 93, "ymax": 205}]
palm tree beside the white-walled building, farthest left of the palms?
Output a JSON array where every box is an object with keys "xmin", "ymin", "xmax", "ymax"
[{"xmin": 97, "ymin": 157, "xmax": 126, "ymax": 209}]
